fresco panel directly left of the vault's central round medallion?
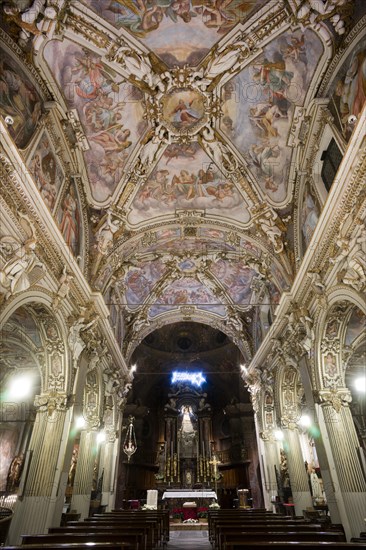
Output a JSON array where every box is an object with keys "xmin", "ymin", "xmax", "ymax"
[{"xmin": 44, "ymin": 40, "xmax": 147, "ymax": 202}]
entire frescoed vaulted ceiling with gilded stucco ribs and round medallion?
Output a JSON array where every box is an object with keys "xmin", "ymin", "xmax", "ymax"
[{"xmin": 1, "ymin": 0, "xmax": 365, "ymax": 366}]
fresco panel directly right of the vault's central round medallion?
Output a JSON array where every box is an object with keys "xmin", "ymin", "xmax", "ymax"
[{"xmin": 221, "ymin": 30, "xmax": 323, "ymax": 203}]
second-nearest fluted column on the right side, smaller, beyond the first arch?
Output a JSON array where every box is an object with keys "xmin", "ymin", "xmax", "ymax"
[{"xmin": 283, "ymin": 428, "xmax": 313, "ymax": 516}]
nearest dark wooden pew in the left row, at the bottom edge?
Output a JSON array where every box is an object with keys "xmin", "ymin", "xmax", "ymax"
[{"xmin": 22, "ymin": 531, "xmax": 146, "ymax": 550}]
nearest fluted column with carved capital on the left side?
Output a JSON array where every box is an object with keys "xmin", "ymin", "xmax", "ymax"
[{"xmin": 7, "ymin": 392, "xmax": 70, "ymax": 545}]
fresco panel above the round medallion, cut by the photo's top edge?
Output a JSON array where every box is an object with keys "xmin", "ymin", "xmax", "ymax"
[{"xmin": 84, "ymin": 0, "xmax": 266, "ymax": 67}]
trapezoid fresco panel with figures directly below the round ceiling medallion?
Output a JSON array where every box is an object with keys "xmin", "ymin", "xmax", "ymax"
[{"xmin": 128, "ymin": 142, "xmax": 249, "ymax": 225}]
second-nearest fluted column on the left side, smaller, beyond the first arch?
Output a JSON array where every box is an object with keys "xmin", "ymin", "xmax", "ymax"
[{"xmin": 71, "ymin": 429, "xmax": 98, "ymax": 519}]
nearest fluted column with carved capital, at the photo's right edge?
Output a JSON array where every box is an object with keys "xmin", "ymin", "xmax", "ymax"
[{"xmin": 319, "ymin": 396, "xmax": 366, "ymax": 540}]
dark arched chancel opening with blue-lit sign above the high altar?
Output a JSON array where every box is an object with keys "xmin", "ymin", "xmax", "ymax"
[{"xmin": 119, "ymin": 321, "xmax": 262, "ymax": 507}]
